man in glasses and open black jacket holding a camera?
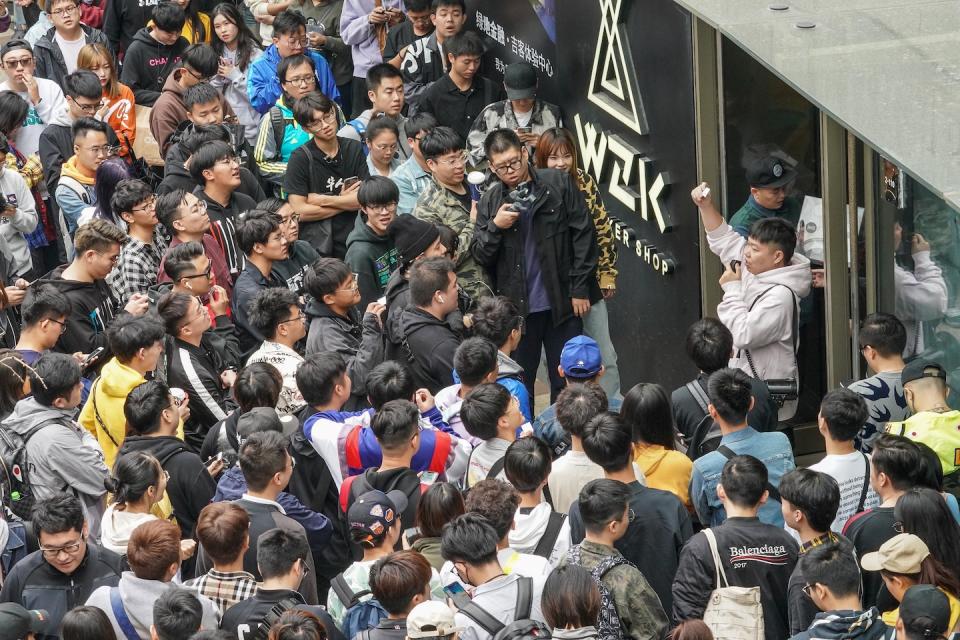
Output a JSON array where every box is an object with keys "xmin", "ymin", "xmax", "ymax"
[{"xmin": 470, "ymin": 129, "xmax": 602, "ymax": 402}]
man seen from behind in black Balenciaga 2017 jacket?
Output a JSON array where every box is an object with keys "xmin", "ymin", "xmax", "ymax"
[{"xmin": 673, "ymin": 456, "xmax": 797, "ymax": 640}]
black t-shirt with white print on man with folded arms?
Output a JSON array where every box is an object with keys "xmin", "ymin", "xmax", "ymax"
[{"xmin": 283, "ymin": 138, "xmax": 370, "ymax": 260}]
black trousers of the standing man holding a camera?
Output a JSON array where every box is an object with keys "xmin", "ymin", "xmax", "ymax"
[{"xmin": 512, "ymin": 311, "xmax": 583, "ymax": 408}]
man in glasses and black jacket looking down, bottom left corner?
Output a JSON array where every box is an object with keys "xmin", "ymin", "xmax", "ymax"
[{"xmin": 0, "ymin": 493, "xmax": 126, "ymax": 640}]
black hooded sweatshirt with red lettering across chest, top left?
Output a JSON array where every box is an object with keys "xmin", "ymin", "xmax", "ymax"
[{"xmin": 118, "ymin": 27, "xmax": 190, "ymax": 107}]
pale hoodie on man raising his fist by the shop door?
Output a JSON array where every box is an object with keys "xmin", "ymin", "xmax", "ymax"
[{"xmin": 707, "ymin": 223, "xmax": 812, "ymax": 420}]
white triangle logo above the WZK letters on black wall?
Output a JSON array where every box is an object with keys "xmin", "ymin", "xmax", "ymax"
[{"xmin": 587, "ymin": 0, "xmax": 649, "ymax": 135}]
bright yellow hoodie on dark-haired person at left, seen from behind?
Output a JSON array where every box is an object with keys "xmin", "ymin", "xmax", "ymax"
[{"xmin": 80, "ymin": 358, "xmax": 183, "ymax": 469}]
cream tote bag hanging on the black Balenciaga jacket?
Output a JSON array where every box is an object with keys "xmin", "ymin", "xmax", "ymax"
[{"xmin": 703, "ymin": 529, "xmax": 764, "ymax": 640}]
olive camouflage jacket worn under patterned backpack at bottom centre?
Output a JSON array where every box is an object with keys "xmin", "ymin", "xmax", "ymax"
[{"xmin": 560, "ymin": 540, "xmax": 669, "ymax": 640}]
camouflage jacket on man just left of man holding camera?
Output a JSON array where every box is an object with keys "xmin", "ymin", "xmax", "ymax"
[{"xmin": 413, "ymin": 180, "xmax": 491, "ymax": 301}]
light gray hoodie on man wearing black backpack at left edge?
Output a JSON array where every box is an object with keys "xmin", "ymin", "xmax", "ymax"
[{"xmin": 2, "ymin": 396, "xmax": 110, "ymax": 541}]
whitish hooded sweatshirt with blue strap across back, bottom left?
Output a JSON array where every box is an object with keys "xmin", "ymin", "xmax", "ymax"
[{"xmin": 87, "ymin": 571, "xmax": 217, "ymax": 638}]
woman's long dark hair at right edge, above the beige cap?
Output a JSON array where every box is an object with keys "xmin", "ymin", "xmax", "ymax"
[{"xmin": 893, "ymin": 487, "xmax": 960, "ymax": 575}]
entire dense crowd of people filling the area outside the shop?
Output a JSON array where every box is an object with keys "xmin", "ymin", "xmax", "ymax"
[{"xmin": 0, "ymin": 0, "xmax": 948, "ymax": 640}]
